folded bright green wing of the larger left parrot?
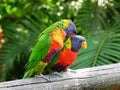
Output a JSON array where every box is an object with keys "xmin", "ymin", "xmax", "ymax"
[{"xmin": 26, "ymin": 35, "xmax": 52, "ymax": 69}]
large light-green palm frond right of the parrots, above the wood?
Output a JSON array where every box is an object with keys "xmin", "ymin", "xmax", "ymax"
[{"xmin": 71, "ymin": 28, "xmax": 120, "ymax": 69}]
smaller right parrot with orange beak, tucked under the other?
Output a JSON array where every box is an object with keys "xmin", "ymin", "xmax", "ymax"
[{"xmin": 43, "ymin": 35, "xmax": 87, "ymax": 74}]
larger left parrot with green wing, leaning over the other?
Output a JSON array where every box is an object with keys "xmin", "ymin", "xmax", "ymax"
[{"xmin": 23, "ymin": 19, "xmax": 77, "ymax": 79}]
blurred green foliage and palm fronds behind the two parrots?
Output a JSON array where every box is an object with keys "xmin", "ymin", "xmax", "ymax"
[{"xmin": 0, "ymin": 0, "xmax": 120, "ymax": 81}]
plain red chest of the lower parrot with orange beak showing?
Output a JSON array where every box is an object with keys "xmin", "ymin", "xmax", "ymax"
[{"xmin": 57, "ymin": 49, "xmax": 78, "ymax": 66}]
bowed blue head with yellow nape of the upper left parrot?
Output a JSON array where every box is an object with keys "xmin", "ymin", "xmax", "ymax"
[{"xmin": 63, "ymin": 20, "xmax": 77, "ymax": 36}]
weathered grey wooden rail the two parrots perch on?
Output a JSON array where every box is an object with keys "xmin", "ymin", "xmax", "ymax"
[{"xmin": 0, "ymin": 63, "xmax": 120, "ymax": 90}]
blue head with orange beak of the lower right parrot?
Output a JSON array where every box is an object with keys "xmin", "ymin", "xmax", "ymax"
[{"xmin": 71, "ymin": 35, "xmax": 87, "ymax": 51}]
